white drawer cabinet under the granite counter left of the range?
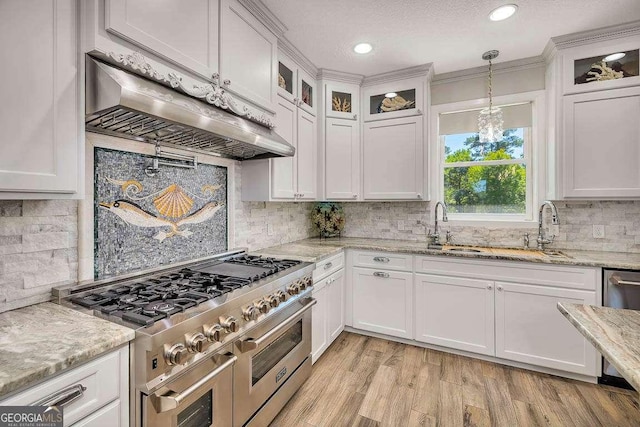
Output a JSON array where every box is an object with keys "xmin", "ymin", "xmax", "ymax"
[{"xmin": 0, "ymin": 347, "xmax": 129, "ymax": 427}]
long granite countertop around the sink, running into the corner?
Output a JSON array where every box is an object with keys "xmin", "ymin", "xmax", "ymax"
[{"xmin": 254, "ymin": 237, "xmax": 640, "ymax": 270}]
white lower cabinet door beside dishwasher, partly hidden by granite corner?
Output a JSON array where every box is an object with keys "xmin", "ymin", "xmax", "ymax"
[{"xmin": 495, "ymin": 282, "xmax": 597, "ymax": 375}]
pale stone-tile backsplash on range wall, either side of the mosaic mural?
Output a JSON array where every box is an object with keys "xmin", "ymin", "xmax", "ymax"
[{"xmin": 0, "ymin": 160, "xmax": 313, "ymax": 312}]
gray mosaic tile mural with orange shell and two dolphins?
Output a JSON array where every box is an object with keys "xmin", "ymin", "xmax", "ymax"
[{"xmin": 94, "ymin": 148, "xmax": 228, "ymax": 279}]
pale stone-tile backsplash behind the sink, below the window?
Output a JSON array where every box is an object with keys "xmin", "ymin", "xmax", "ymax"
[{"xmin": 344, "ymin": 201, "xmax": 640, "ymax": 253}]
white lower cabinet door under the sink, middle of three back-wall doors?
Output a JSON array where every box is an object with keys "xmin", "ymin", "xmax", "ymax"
[{"xmin": 415, "ymin": 274, "xmax": 496, "ymax": 356}]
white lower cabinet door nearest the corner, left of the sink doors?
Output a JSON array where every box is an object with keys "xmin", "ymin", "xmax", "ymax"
[{"xmin": 351, "ymin": 267, "xmax": 413, "ymax": 338}]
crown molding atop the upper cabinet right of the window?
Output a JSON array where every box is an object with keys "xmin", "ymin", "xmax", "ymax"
[{"xmin": 542, "ymin": 21, "xmax": 640, "ymax": 62}]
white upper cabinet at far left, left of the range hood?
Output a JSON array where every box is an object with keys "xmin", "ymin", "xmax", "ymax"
[{"xmin": 0, "ymin": 0, "xmax": 84, "ymax": 199}]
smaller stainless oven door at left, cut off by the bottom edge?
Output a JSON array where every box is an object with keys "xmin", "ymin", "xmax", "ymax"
[{"xmin": 142, "ymin": 353, "xmax": 237, "ymax": 427}]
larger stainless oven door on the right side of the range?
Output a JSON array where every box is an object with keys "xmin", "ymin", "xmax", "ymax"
[{"xmin": 233, "ymin": 298, "xmax": 316, "ymax": 426}]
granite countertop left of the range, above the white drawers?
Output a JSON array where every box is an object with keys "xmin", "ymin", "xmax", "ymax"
[{"xmin": 0, "ymin": 302, "xmax": 135, "ymax": 399}]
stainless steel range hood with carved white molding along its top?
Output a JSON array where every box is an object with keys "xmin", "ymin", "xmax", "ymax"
[{"xmin": 85, "ymin": 52, "xmax": 295, "ymax": 160}]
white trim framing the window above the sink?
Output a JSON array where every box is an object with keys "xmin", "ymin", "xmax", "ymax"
[{"xmin": 429, "ymin": 90, "xmax": 547, "ymax": 228}]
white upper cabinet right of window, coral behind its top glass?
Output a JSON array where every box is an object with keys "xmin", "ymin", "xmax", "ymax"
[{"xmin": 546, "ymin": 32, "xmax": 640, "ymax": 200}]
